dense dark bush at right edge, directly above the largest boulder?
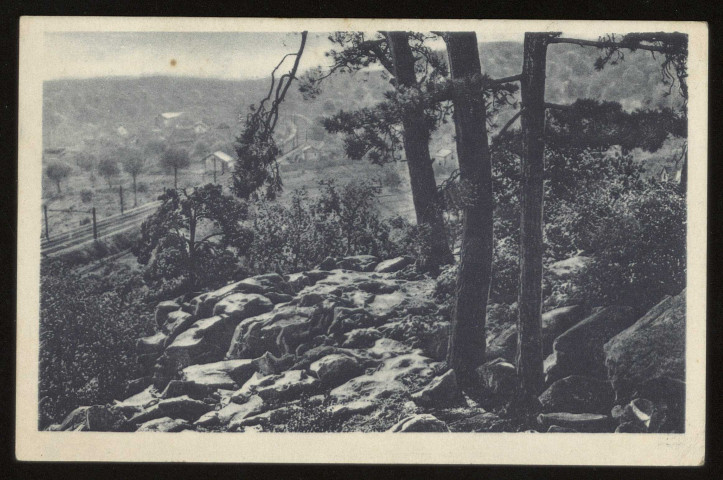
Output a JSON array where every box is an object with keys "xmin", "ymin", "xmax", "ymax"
[{"xmin": 579, "ymin": 183, "xmax": 686, "ymax": 312}]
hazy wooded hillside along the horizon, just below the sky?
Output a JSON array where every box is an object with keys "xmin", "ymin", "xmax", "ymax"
[{"xmin": 43, "ymin": 42, "xmax": 680, "ymax": 149}]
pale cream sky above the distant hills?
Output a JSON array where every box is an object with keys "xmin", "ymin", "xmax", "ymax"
[{"xmin": 44, "ymin": 32, "xmax": 522, "ymax": 80}]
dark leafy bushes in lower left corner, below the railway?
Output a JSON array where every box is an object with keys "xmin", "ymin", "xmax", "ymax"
[{"xmin": 39, "ymin": 261, "xmax": 153, "ymax": 428}]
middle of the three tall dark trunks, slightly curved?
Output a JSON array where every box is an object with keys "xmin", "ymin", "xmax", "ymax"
[{"xmin": 444, "ymin": 32, "xmax": 493, "ymax": 384}]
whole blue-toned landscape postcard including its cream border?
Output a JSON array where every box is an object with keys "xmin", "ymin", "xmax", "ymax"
[{"xmin": 17, "ymin": 17, "xmax": 708, "ymax": 465}]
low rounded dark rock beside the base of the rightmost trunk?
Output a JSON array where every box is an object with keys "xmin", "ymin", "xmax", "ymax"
[{"xmin": 539, "ymin": 375, "xmax": 615, "ymax": 413}]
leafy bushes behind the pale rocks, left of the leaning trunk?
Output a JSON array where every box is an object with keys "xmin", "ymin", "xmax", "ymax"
[{"xmin": 248, "ymin": 180, "xmax": 406, "ymax": 273}]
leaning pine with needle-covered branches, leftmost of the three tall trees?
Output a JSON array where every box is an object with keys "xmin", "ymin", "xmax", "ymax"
[{"xmin": 308, "ymin": 32, "xmax": 453, "ymax": 272}]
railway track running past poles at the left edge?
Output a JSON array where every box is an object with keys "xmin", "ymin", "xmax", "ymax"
[{"xmin": 40, "ymin": 201, "xmax": 161, "ymax": 257}]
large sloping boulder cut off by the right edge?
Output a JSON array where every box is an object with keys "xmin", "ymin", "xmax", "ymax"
[{"xmin": 604, "ymin": 290, "xmax": 686, "ymax": 403}]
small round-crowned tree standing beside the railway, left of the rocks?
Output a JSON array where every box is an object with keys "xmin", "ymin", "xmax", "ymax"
[{"xmin": 133, "ymin": 184, "xmax": 252, "ymax": 288}]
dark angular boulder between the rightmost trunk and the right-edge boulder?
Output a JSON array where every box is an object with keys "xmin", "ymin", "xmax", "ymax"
[{"xmin": 545, "ymin": 307, "xmax": 635, "ymax": 383}]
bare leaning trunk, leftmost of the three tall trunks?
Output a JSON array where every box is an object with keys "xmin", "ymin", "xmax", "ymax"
[{"xmin": 385, "ymin": 32, "xmax": 454, "ymax": 272}]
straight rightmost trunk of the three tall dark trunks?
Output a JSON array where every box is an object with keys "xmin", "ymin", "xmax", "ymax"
[{"xmin": 517, "ymin": 32, "xmax": 550, "ymax": 404}]
